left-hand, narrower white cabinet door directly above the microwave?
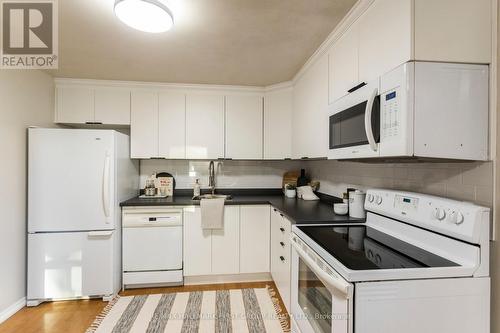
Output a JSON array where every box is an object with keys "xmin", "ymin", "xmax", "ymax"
[{"xmin": 328, "ymin": 22, "xmax": 359, "ymax": 104}]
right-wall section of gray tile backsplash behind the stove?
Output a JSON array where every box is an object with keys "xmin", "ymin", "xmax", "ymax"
[{"xmin": 304, "ymin": 161, "xmax": 493, "ymax": 207}]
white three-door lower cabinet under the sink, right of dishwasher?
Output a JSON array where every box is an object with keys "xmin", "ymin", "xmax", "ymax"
[{"xmin": 184, "ymin": 205, "xmax": 270, "ymax": 277}]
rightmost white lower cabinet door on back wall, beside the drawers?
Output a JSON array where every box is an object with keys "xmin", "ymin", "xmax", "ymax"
[{"xmin": 240, "ymin": 205, "xmax": 271, "ymax": 273}]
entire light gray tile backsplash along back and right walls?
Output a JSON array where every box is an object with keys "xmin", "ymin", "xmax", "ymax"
[{"xmin": 141, "ymin": 160, "xmax": 493, "ymax": 207}]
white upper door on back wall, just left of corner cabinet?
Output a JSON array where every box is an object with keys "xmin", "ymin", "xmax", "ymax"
[{"xmin": 226, "ymin": 96, "xmax": 262, "ymax": 159}]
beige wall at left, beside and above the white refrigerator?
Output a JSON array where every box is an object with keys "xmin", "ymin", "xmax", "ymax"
[{"xmin": 0, "ymin": 70, "xmax": 54, "ymax": 315}]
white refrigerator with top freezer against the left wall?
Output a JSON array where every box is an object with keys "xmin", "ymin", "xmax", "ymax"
[{"xmin": 27, "ymin": 128, "xmax": 139, "ymax": 306}]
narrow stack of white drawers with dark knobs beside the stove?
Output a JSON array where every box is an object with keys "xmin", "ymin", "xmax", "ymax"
[{"xmin": 271, "ymin": 208, "xmax": 292, "ymax": 312}]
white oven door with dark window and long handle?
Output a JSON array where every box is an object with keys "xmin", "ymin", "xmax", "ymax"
[{"xmin": 291, "ymin": 235, "xmax": 354, "ymax": 333}]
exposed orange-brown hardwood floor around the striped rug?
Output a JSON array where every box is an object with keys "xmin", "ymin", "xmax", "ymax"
[{"xmin": 0, "ymin": 281, "xmax": 286, "ymax": 333}]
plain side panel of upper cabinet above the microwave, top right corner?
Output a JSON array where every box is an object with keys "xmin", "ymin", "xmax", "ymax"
[{"xmin": 414, "ymin": 0, "xmax": 494, "ymax": 64}]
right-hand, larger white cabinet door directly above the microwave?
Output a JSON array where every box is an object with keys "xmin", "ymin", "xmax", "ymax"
[{"xmin": 358, "ymin": 0, "xmax": 412, "ymax": 82}]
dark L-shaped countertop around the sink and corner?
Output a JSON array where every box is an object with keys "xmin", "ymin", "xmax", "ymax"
[{"xmin": 120, "ymin": 189, "xmax": 364, "ymax": 224}]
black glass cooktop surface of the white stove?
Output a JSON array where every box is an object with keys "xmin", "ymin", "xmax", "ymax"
[{"xmin": 298, "ymin": 226, "xmax": 459, "ymax": 270}]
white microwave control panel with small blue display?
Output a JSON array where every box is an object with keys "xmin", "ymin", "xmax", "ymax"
[{"xmin": 380, "ymin": 89, "xmax": 401, "ymax": 139}]
